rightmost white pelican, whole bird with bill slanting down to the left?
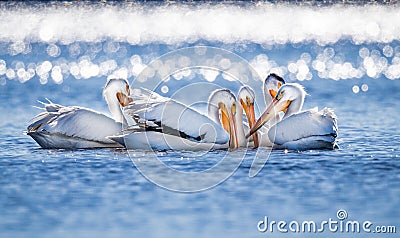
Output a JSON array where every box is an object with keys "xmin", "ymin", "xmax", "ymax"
[{"xmin": 246, "ymin": 83, "xmax": 338, "ymax": 150}]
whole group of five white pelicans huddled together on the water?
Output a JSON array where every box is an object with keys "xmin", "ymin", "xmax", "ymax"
[{"xmin": 28, "ymin": 74, "xmax": 338, "ymax": 150}]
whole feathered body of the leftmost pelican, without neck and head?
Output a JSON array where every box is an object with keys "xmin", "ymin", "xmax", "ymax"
[{"xmin": 27, "ymin": 103, "xmax": 122, "ymax": 149}]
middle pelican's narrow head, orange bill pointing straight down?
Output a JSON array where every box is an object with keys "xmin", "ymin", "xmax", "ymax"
[{"xmin": 238, "ymin": 85, "xmax": 259, "ymax": 148}]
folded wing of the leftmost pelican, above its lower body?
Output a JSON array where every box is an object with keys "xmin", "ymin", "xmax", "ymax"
[{"xmin": 28, "ymin": 103, "xmax": 122, "ymax": 143}]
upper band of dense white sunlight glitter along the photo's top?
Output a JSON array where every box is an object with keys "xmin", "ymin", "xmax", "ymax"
[{"xmin": 0, "ymin": 2, "xmax": 400, "ymax": 44}]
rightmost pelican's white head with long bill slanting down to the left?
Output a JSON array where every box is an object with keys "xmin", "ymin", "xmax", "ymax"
[{"xmin": 246, "ymin": 83, "xmax": 306, "ymax": 138}]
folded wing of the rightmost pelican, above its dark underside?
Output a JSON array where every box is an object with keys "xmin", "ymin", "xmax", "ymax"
[{"xmin": 268, "ymin": 108, "xmax": 338, "ymax": 145}]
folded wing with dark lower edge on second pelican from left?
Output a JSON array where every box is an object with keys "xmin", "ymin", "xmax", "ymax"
[{"xmin": 124, "ymin": 91, "xmax": 229, "ymax": 144}]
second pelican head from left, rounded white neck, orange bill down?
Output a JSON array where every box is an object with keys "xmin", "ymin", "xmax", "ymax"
[{"xmin": 208, "ymin": 89, "xmax": 239, "ymax": 148}]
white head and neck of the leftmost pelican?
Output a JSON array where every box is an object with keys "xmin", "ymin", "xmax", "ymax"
[{"xmin": 103, "ymin": 78, "xmax": 132, "ymax": 123}]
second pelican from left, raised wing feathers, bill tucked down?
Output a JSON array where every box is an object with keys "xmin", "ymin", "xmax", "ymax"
[{"xmin": 109, "ymin": 89, "xmax": 236, "ymax": 150}]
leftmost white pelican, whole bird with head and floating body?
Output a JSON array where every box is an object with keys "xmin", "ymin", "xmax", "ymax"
[{"xmin": 27, "ymin": 79, "xmax": 130, "ymax": 149}]
